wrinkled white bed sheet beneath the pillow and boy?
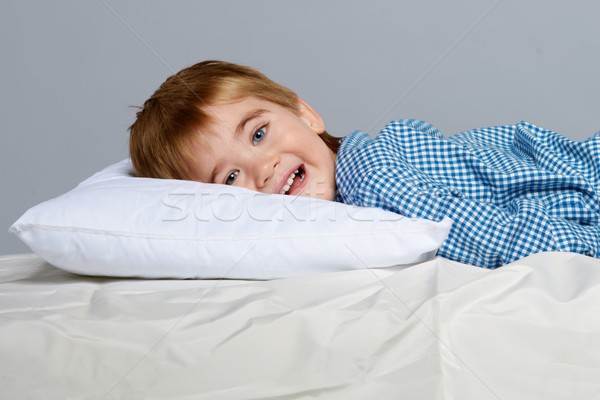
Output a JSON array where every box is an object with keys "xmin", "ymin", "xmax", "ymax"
[{"xmin": 0, "ymin": 253, "xmax": 600, "ymax": 400}]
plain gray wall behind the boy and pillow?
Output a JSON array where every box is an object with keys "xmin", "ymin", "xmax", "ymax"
[{"xmin": 0, "ymin": 0, "xmax": 600, "ymax": 254}]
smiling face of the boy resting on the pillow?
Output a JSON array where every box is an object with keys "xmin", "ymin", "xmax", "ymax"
[{"xmin": 192, "ymin": 97, "xmax": 336, "ymax": 200}]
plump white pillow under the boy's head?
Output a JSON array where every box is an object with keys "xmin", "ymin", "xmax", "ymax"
[{"xmin": 10, "ymin": 160, "xmax": 451, "ymax": 279}]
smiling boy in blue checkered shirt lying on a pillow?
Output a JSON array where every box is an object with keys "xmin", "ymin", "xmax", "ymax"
[{"xmin": 130, "ymin": 61, "xmax": 600, "ymax": 268}]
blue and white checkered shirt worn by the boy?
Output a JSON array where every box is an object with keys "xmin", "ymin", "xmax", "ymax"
[{"xmin": 336, "ymin": 120, "xmax": 600, "ymax": 268}]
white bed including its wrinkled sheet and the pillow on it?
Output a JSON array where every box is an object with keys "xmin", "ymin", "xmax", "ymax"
[{"xmin": 0, "ymin": 160, "xmax": 600, "ymax": 400}]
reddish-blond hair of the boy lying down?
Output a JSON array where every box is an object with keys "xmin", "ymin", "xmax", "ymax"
[{"xmin": 129, "ymin": 60, "xmax": 340, "ymax": 179}]
